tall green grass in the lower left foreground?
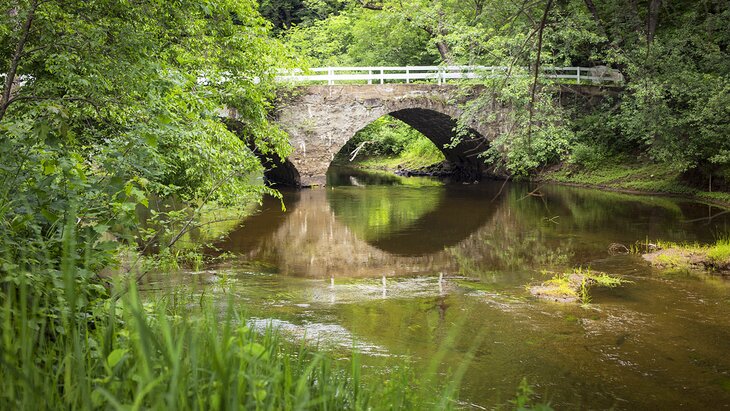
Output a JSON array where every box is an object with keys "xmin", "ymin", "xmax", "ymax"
[{"xmin": 0, "ymin": 224, "xmax": 463, "ymax": 410}]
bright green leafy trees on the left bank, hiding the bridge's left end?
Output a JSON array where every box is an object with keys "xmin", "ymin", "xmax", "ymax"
[{"xmin": 0, "ymin": 0, "xmax": 288, "ymax": 288}]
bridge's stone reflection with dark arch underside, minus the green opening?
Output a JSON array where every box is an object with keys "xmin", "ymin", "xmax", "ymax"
[{"xmin": 209, "ymin": 187, "xmax": 498, "ymax": 278}]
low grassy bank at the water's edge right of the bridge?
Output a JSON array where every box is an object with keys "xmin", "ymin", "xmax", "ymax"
[{"xmin": 538, "ymin": 160, "xmax": 730, "ymax": 205}]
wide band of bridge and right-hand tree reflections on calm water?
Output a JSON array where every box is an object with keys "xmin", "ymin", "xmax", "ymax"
[{"xmin": 210, "ymin": 176, "xmax": 730, "ymax": 278}]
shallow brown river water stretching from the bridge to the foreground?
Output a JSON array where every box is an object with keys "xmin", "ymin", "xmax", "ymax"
[{"xmin": 145, "ymin": 168, "xmax": 730, "ymax": 409}]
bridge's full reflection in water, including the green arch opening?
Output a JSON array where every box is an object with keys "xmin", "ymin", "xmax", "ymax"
[{"xmin": 216, "ymin": 181, "xmax": 504, "ymax": 278}]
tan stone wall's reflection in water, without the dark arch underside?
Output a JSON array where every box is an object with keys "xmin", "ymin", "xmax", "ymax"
[{"xmin": 216, "ymin": 190, "xmax": 460, "ymax": 278}]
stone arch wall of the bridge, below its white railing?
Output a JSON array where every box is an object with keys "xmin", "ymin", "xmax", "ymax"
[{"xmin": 269, "ymin": 84, "xmax": 502, "ymax": 186}]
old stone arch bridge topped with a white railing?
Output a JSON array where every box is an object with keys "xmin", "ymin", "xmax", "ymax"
[{"xmin": 228, "ymin": 66, "xmax": 623, "ymax": 187}]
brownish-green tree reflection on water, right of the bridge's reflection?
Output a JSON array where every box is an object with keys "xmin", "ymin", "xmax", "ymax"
[{"xmin": 440, "ymin": 184, "xmax": 720, "ymax": 277}]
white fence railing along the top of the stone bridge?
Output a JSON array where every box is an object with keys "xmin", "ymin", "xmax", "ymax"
[{"xmin": 276, "ymin": 66, "xmax": 624, "ymax": 85}]
